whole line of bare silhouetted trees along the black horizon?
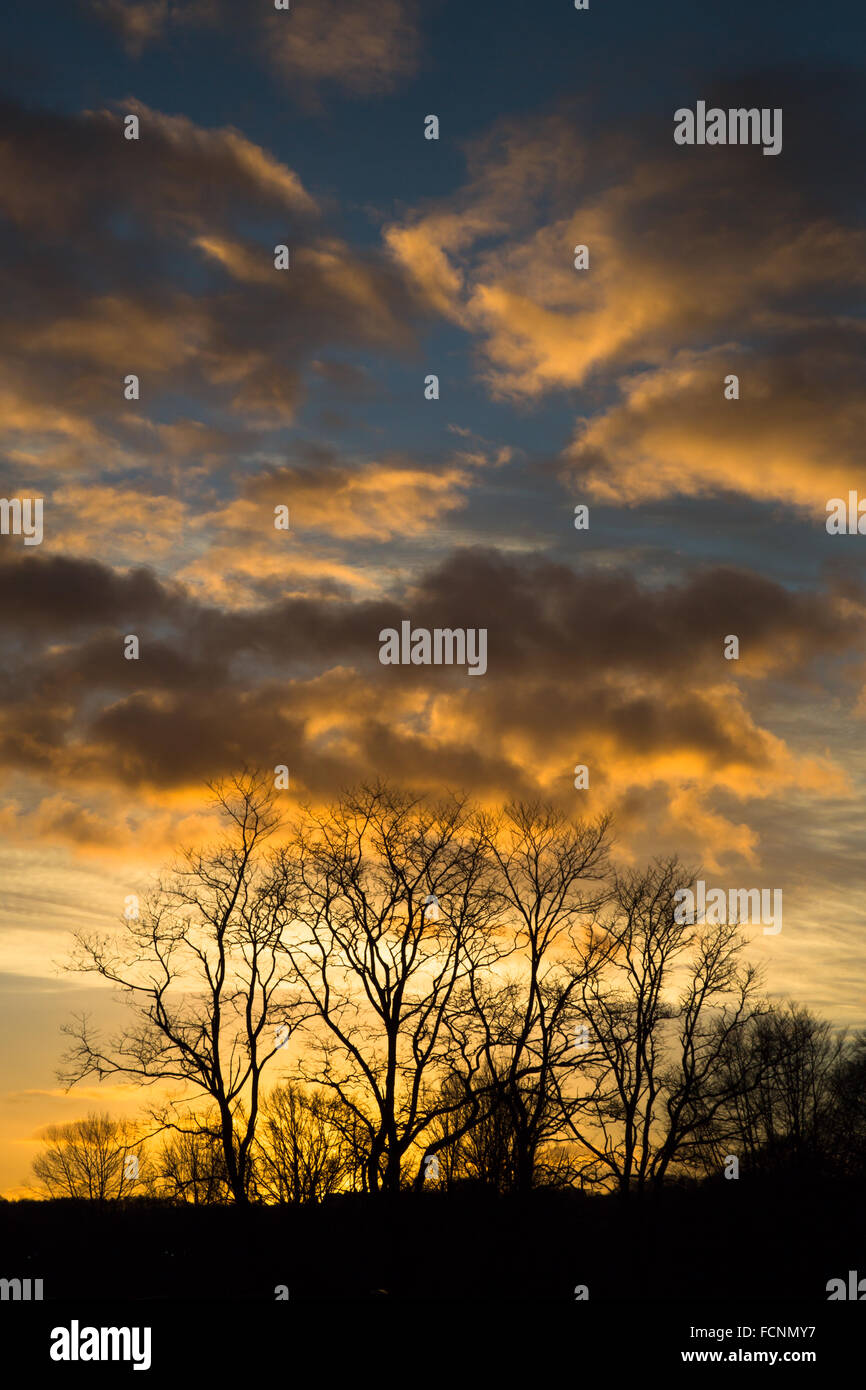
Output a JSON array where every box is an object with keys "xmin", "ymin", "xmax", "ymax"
[{"xmin": 35, "ymin": 773, "xmax": 866, "ymax": 1204}]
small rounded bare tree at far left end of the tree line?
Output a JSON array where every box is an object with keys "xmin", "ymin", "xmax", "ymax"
[{"xmin": 33, "ymin": 1112, "xmax": 147, "ymax": 1202}]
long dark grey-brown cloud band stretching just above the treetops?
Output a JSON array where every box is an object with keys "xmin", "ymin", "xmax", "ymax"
[{"xmin": 1, "ymin": 550, "xmax": 865, "ymax": 788}]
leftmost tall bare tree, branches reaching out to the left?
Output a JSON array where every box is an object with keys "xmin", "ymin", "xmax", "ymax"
[{"xmin": 61, "ymin": 773, "xmax": 297, "ymax": 1202}]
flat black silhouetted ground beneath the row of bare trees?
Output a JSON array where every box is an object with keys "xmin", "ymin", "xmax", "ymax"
[{"xmin": 0, "ymin": 1180, "xmax": 866, "ymax": 1302}]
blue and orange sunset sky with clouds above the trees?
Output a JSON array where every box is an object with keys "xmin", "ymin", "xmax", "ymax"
[{"xmin": 0, "ymin": 0, "xmax": 866, "ymax": 1193}]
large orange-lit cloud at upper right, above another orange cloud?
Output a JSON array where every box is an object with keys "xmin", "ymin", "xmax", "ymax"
[{"xmin": 385, "ymin": 118, "xmax": 866, "ymax": 398}]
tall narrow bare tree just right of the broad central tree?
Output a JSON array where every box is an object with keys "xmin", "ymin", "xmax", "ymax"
[{"xmin": 439, "ymin": 802, "xmax": 613, "ymax": 1191}]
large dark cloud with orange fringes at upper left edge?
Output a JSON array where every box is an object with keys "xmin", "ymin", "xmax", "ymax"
[{"xmin": 0, "ymin": 100, "xmax": 416, "ymax": 471}]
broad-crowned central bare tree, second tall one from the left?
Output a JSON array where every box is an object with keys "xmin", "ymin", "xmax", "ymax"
[{"xmin": 284, "ymin": 784, "xmax": 495, "ymax": 1193}]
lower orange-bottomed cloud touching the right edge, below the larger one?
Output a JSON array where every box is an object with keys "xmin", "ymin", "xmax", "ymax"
[{"xmin": 563, "ymin": 333, "xmax": 866, "ymax": 508}]
